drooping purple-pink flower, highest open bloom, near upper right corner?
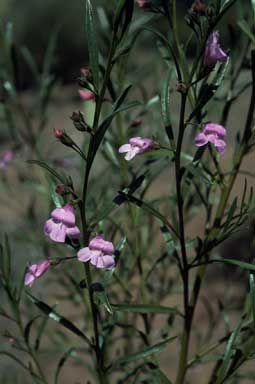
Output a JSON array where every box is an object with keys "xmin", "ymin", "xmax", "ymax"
[{"xmin": 204, "ymin": 32, "xmax": 228, "ymax": 68}]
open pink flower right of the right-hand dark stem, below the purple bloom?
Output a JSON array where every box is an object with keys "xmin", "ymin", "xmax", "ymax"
[{"xmin": 195, "ymin": 123, "xmax": 226, "ymax": 154}]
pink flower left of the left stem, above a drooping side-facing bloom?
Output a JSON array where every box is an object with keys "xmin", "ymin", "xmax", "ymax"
[{"xmin": 44, "ymin": 204, "xmax": 80, "ymax": 243}]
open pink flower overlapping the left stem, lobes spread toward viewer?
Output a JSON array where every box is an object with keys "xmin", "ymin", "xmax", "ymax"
[{"xmin": 77, "ymin": 235, "xmax": 115, "ymax": 269}]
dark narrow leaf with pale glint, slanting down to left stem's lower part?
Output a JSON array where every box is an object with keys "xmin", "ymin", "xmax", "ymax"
[{"xmin": 26, "ymin": 292, "xmax": 90, "ymax": 345}]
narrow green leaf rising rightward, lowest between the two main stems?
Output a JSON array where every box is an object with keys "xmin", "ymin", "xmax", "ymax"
[{"xmin": 109, "ymin": 336, "xmax": 177, "ymax": 367}]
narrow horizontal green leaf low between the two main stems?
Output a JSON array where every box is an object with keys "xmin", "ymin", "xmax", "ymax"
[{"xmin": 111, "ymin": 303, "xmax": 180, "ymax": 315}]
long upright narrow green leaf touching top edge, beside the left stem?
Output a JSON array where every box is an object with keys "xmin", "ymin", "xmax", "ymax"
[{"xmin": 85, "ymin": 0, "xmax": 99, "ymax": 91}]
